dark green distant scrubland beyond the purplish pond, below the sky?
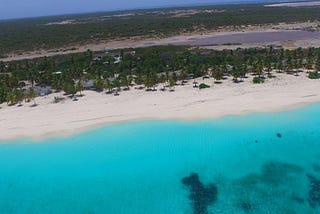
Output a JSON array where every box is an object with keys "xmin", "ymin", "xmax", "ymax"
[{"xmin": 0, "ymin": 5, "xmax": 320, "ymax": 58}]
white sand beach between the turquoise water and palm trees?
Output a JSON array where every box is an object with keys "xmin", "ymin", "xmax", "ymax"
[{"xmin": 0, "ymin": 73, "xmax": 320, "ymax": 141}]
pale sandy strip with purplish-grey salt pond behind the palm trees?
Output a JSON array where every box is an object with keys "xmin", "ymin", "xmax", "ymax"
[{"xmin": 0, "ymin": 21, "xmax": 320, "ymax": 62}]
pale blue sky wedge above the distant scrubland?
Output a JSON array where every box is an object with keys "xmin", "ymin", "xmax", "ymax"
[{"xmin": 0, "ymin": 0, "xmax": 298, "ymax": 19}]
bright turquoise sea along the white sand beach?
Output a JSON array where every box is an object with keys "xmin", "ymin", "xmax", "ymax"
[{"xmin": 0, "ymin": 104, "xmax": 320, "ymax": 214}]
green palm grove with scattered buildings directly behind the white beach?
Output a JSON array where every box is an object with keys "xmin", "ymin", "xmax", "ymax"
[{"xmin": 0, "ymin": 46, "xmax": 320, "ymax": 105}]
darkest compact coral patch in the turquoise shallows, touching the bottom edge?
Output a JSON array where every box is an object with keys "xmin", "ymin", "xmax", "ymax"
[{"xmin": 182, "ymin": 173, "xmax": 218, "ymax": 214}]
